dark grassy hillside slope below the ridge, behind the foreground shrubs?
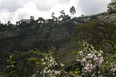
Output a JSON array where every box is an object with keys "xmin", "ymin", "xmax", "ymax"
[{"xmin": 0, "ymin": 13, "xmax": 116, "ymax": 72}]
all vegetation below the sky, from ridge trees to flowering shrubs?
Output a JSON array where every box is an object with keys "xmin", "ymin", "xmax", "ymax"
[{"xmin": 0, "ymin": 0, "xmax": 116, "ymax": 77}]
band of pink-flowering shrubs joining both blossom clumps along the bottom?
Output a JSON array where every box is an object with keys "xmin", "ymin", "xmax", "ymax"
[{"xmin": 32, "ymin": 42, "xmax": 116, "ymax": 77}]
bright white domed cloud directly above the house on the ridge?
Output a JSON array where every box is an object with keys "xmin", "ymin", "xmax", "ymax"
[{"xmin": 11, "ymin": 1, "xmax": 47, "ymax": 23}]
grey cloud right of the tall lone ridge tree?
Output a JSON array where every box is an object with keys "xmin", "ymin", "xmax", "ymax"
[{"xmin": 77, "ymin": 0, "xmax": 110, "ymax": 14}]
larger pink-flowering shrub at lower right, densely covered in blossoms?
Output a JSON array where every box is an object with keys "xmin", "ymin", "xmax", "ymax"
[{"xmin": 77, "ymin": 42, "xmax": 116, "ymax": 77}]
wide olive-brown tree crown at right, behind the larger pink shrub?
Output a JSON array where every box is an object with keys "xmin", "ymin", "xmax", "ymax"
[{"xmin": 75, "ymin": 20, "xmax": 116, "ymax": 53}]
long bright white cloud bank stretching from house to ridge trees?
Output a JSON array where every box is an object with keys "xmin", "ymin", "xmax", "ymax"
[{"xmin": 11, "ymin": 0, "xmax": 73, "ymax": 23}]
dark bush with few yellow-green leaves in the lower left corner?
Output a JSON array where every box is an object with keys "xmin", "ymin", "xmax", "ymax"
[{"xmin": 7, "ymin": 52, "xmax": 35, "ymax": 77}]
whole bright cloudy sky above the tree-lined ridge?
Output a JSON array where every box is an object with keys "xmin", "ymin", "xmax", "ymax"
[{"xmin": 0, "ymin": 0, "xmax": 110, "ymax": 24}]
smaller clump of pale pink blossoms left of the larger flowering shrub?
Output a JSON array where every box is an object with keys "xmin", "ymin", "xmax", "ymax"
[{"xmin": 40, "ymin": 53, "xmax": 62, "ymax": 77}]
